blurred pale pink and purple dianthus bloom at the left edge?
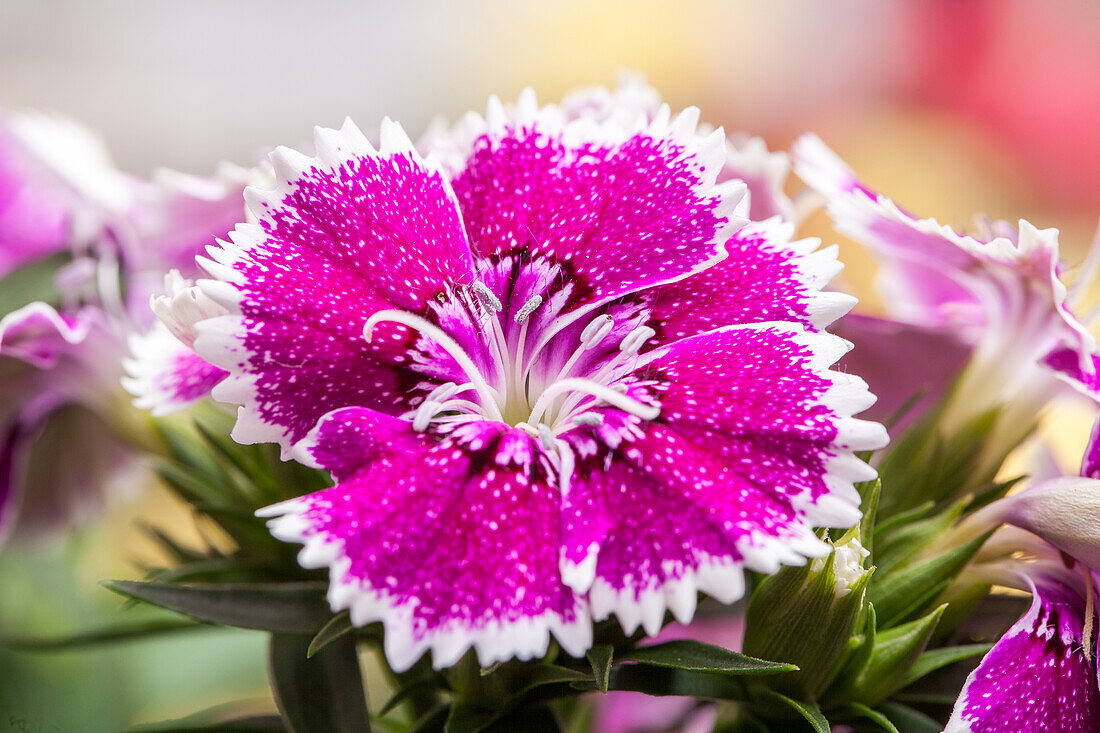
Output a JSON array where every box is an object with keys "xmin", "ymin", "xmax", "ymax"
[{"xmin": 0, "ymin": 113, "xmax": 244, "ymax": 541}]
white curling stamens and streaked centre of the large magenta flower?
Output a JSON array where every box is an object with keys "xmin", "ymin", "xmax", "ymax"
[{"xmin": 364, "ymin": 256, "xmax": 659, "ymax": 433}]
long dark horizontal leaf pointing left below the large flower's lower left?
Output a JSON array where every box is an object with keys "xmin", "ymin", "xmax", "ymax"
[{"xmin": 102, "ymin": 580, "xmax": 332, "ymax": 629}]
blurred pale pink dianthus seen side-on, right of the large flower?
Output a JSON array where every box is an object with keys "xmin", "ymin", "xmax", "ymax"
[{"xmin": 792, "ymin": 134, "xmax": 1100, "ymax": 428}]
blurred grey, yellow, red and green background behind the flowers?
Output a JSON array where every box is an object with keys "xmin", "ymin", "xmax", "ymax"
[{"xmin": 0, "ymin": 0, "xmax": 1100, "ymax": 733}]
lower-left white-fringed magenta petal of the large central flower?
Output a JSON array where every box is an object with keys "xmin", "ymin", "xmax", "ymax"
[{"xmin": 263, "ymin": 415, "xmax": 592, "ymax": 670}]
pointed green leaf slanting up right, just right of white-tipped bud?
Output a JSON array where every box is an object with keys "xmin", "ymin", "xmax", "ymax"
[{"xmin": 870, "ymin": 532, "xmax": 992, "ymax": 626}]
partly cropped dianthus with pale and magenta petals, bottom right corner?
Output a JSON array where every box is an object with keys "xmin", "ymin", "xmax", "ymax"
[{"xmin": 946, "ymin": 423, "xmax": 1100, "ymax": 733}]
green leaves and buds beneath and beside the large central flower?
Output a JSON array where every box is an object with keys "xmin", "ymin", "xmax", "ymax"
[{"xmin": 64, "ymin": 372, "xmax": 1029, "ymax": 733}]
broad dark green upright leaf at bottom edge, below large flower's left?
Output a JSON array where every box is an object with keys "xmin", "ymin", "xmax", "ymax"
[{"xmin": 268, "ymin": 634, "xmax": 371, "ymax": 733}]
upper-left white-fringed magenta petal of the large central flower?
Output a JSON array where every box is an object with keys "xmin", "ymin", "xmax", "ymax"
[{"xmin": 195, "ymin": 122, "xmax": 473, "ymax": 449}]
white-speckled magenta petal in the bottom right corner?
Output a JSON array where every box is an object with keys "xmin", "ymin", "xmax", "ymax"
[{"xmin": 945, "ymin": 584, "xmax": 1100, "ymax": 733}]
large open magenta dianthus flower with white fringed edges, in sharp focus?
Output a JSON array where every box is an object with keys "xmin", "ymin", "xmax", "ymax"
[{"xmin": 195, "ymin": 92, "xmax": 886, "ymax": 670}]
